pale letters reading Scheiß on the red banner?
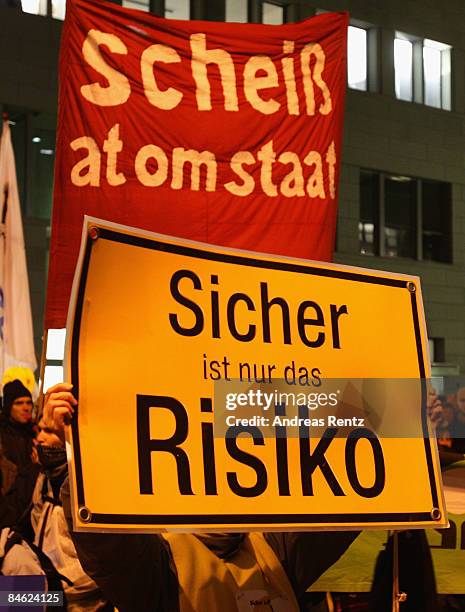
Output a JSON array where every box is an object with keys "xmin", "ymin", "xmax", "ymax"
[{"xmin": 81, "ymin": 30, "xmax": 333, "ymax": 116}]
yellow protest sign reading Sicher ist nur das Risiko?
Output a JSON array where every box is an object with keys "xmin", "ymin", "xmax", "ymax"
[{"xmin": 66, "ymin": 218, "xmax": 446, "ymax": 531}]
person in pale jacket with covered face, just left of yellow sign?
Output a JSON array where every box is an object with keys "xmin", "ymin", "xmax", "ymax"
[{"xmin": 0, "ymin": 420, "xmax": 114, "ymax": 612}]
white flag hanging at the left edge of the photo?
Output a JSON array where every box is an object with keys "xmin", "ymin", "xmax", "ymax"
[{"xmin": 0, "ymin": 120, "xmax": 37, "ymax": 375}]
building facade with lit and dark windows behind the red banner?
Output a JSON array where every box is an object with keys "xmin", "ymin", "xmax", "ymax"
[{"xmin": 0, "ymin": 0, "xmax": 465, "ymax": 374}]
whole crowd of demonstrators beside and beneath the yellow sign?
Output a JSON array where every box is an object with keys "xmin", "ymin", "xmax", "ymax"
[{"xmin": 0, "ymin": 368, "xmax": 465, "ymax": 612}]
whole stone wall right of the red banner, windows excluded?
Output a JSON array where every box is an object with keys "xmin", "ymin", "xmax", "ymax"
[{"xmin": 319, "ymin": 0, "xmax": 465, "ymax": 373}]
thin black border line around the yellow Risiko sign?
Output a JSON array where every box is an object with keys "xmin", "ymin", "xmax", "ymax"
[{"xmin": 71, "ymin": 227, "xmax": 438, "ymax": 526}]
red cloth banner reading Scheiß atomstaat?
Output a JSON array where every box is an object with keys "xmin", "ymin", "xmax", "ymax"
[{"xmin": 45, "ymin": 0, "xmax": 348, "ymax": 328}]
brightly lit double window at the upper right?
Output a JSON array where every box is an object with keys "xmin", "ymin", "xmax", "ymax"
[{"xmin": 394, "ymin": 32, "xmax": 451, "ymax": 110}]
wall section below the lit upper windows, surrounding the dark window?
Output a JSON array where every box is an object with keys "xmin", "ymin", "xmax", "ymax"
[{"xmin": 335, "ymin": 91, "xmax": 465, "ymax": 372}]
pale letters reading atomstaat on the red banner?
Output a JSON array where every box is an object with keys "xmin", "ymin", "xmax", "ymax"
[{"xmin": 70, "ymin": 123, "xmax": 336, "ymax": 200}]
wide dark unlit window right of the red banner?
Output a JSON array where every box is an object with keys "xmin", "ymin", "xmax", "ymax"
[{"xmin": 359, "ymin": 170, "xmax": 452, "ymax": 263}]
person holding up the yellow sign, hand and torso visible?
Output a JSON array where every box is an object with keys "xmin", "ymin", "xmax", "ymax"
[{"xmin": 43, "ymin": 384, "xmax": 358, "ymax": 612}]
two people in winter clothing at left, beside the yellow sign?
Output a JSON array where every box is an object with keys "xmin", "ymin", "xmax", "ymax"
[{"xmin": 0, "ymin": 372, "xmax": 110, "ymax": 612}]
